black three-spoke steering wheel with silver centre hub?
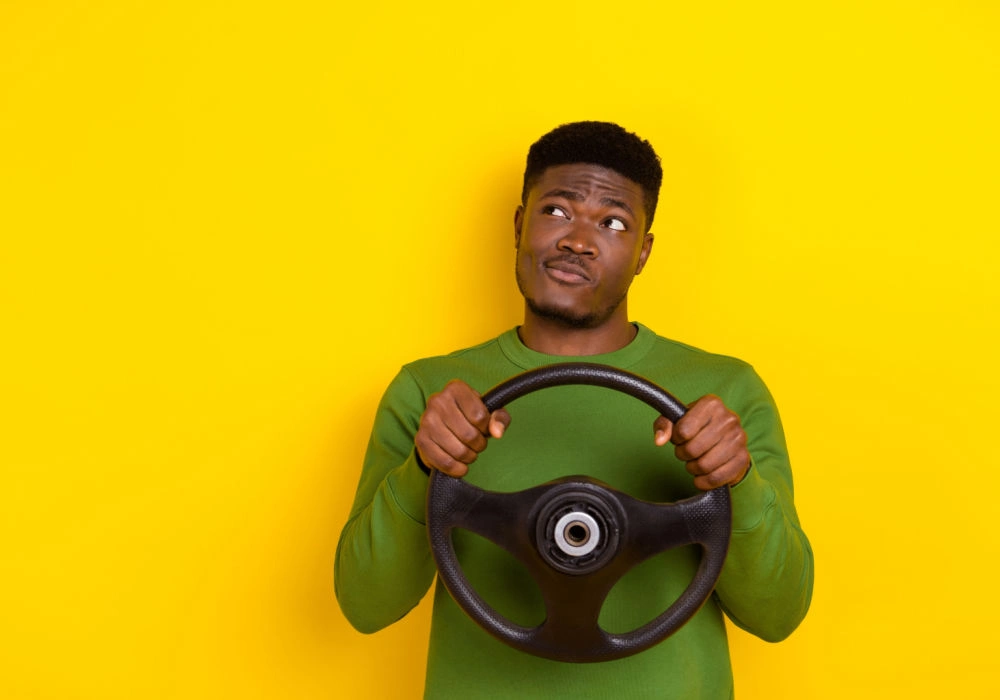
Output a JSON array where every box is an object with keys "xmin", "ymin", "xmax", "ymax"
[{"xmin": 427, "ymin": 363, "xmax": 732, "ymax": 662}]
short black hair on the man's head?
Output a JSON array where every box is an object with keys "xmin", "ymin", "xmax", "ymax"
[{"xmin": 521, "ymin": 121, "xmax": 663, "ymax": 231}]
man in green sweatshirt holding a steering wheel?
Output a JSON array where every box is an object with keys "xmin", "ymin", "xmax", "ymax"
[{"xmin": 335, "ymin": 122, "xmax": 813, "ymax": 699}]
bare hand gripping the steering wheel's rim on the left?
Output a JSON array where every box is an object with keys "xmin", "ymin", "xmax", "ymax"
[{"xmin": 413, "ymin": 379, "xmax": 510, "ymax": 476}]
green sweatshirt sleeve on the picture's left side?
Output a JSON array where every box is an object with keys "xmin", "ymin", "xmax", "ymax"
[{"xmin": 334, "ymin": 368, "xmax": 435, "ymax": 633}]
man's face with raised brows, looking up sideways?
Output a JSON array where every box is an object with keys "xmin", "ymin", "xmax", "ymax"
[{"xmin": 514, "ymin": 163, "xmax": 653, "ymax": 328}]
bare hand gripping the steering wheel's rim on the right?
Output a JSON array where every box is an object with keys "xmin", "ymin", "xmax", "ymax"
[{"xmin": 653, "ymin": 394, "xmax": 750, "ymax": 491}]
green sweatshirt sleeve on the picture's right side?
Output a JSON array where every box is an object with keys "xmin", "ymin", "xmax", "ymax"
[{"xmin": 715, "ymin": 367, "xmax": 813, "ymax": 642}]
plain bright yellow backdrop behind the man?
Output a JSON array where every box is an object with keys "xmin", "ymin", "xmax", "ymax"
[{"xmin": 0, "ymin": 0, "xmax": 1000, "ymax": 700}]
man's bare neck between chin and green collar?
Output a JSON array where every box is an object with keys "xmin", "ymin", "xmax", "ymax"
[{"xmin": 518, "ymin": 310, "xmax": 637, "ymax": 357}]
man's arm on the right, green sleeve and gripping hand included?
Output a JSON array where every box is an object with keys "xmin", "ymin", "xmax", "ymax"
[{"xmin": 654, "ymin": 367, "xmax": 813, "ymax": 642}]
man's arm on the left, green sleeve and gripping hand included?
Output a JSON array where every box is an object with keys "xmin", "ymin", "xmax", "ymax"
[{"xmin": 334, "ymin": 368, "xmax": 510, "ymax": 632}]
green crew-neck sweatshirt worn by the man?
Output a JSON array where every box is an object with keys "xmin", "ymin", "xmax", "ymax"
[{"xmin": 335, "ymin": 325, "xmax": 813, "ymax": 700}]
